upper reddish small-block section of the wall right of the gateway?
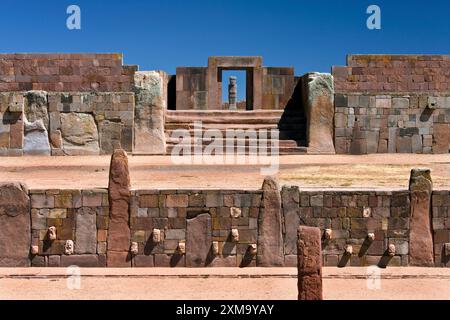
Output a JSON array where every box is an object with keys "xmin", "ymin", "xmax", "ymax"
[{"xmin": 333, "ymin": 55, "xmax": 450, "ymax": 93}]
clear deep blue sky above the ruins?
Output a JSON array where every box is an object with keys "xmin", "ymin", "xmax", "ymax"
[{"xmin": 0, "ymin": 0, "xmax": 450, "ymax": 99}]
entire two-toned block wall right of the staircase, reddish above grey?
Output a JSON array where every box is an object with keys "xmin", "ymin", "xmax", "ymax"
[{"xmin": 332, "ymin": 55, "xmax": 450, "ymax": 154}]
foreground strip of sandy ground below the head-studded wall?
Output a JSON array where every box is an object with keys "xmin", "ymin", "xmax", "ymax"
[{"xmin": 0, "ymin": 267, "xmax": 450, "ymax": 300}]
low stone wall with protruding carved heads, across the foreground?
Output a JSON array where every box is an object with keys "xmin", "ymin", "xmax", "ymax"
[{"xmin": 0, "ymin": 185, "xmax": 450, "ymax": 267}]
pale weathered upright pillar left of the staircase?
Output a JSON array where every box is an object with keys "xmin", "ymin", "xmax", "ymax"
[{"xmin": 134, "ymin": 71, "xmax": 167, "ymax": 154}]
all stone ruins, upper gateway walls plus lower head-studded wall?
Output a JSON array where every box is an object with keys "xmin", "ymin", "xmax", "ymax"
[{"xmin": 0, "ymin": 54, "xmax": 450, "ymax": 268}]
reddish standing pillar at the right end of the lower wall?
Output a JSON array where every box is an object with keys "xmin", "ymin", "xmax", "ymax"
[{"xmin": 409, "ymin": 169, "xmax": 434, "ymax": 267}]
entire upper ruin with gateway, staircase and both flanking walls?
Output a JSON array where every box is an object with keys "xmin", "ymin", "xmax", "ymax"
[{"xmin": 0, "ymin": 54, "xmax": 450, "ymax": 156}]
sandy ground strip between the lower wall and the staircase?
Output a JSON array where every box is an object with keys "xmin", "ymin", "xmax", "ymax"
[{"xmin": 0, "ymin": 154, "xmax": 450, "ymax": 189}]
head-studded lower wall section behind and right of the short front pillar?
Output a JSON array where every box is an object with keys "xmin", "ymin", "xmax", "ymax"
[{"xmin": 281, "ymin": 186, "xmax": 410, "ymax": 266}]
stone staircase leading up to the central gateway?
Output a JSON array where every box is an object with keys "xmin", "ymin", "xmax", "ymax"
[{"xmin": 165, "ymin": 110, "xmax": 306, "ymax": 155}]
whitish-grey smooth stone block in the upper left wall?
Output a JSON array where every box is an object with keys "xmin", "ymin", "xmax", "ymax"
[{"xmin": 23, "ymin": 118, "xmax": 50, "ymax": 155}]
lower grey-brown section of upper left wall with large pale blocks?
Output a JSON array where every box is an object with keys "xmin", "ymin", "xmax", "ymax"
[{"xmin": 0, "ymin": 91, "xmax": 135, "ymax": 156}]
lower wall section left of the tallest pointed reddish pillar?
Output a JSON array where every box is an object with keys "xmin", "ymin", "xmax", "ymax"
[{"xmin": 30, "ymin": 189, "xmax": 109, "ymax": 267}]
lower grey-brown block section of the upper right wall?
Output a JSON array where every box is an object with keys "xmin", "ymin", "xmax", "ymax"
[{"xmin": 334, "ymin": 93, "xmax": 450, "ymax": 154}]
